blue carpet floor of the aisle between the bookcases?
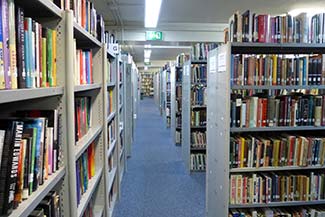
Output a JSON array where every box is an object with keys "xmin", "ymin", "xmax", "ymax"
[{"xmin": 113, "ymin": 98, "xmax": 205, "ymax": 217}]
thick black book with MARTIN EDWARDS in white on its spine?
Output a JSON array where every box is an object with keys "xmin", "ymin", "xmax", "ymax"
[{"xmin": 0, "ymin": 119, "xmax": 24, "ymax": 215}]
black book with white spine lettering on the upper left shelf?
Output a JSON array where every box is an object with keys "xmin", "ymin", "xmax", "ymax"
[{"xmin": 15, "ymin": 7, "xmax": 26, "ymax": 88}]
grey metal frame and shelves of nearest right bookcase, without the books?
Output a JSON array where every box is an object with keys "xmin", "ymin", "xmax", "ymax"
[{"xmin": 206, "ymin": 43, "xmax": 325, "ymax": 217}]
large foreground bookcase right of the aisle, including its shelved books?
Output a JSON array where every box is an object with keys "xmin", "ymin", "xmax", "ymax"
[{"xmin": 206, "ymin": 42, "xmax": 325, "ymax": 217}]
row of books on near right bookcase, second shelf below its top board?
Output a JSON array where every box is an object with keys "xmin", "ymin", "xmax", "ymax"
[{"xmin": 231, "ymin": 93, "xmax": 325, "ymax": 128}]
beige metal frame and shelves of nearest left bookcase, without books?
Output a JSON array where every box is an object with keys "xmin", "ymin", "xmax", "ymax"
[{"xmin": 0, "ymin": 0, "xmax": 69, "ymax": 217}]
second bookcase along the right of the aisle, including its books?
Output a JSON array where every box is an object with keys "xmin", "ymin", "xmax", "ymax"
[{"xmin": 181, "ymin": 60, "xmax": 207, "ymax": 172}]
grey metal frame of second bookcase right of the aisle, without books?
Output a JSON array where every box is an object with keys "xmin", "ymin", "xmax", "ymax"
[{"xmin": 181, "ymin": 60, "xmax": 206, "ymax": 172}]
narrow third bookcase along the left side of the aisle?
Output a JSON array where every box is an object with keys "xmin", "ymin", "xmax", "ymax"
[{"xmin": 103, "ymin": 45, "xmax": 119, "ymax": 216}]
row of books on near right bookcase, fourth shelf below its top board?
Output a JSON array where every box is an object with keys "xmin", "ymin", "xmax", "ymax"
[{"xmin": 229, "ymin": 172, "xmax": 325, "ymax": 204}]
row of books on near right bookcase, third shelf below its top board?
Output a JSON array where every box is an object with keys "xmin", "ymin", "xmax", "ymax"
[{"xmin": 229, "ymin": 135, "xmax": 325, "ymax": 168}]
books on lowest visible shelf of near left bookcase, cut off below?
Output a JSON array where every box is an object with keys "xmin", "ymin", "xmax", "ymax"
[{"xmin": 28, "ymin": 191, "xmax": 62, "ymax": 217}]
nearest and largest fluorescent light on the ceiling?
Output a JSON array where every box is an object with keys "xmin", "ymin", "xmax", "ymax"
[{"xmin": 144, "ymin": 0, "xmax": 162, "ymax": 28}]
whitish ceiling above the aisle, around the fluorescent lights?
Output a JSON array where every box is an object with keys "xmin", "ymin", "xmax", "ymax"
[{"xmin": 94, "ymin": 0, "xmax": 325, "ymax": 68}]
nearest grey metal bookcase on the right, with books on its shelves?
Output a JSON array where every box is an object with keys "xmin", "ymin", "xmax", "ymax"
[{"xmin": 206, "ymin": 42, "xmax": 325, "ymax": 217}]
